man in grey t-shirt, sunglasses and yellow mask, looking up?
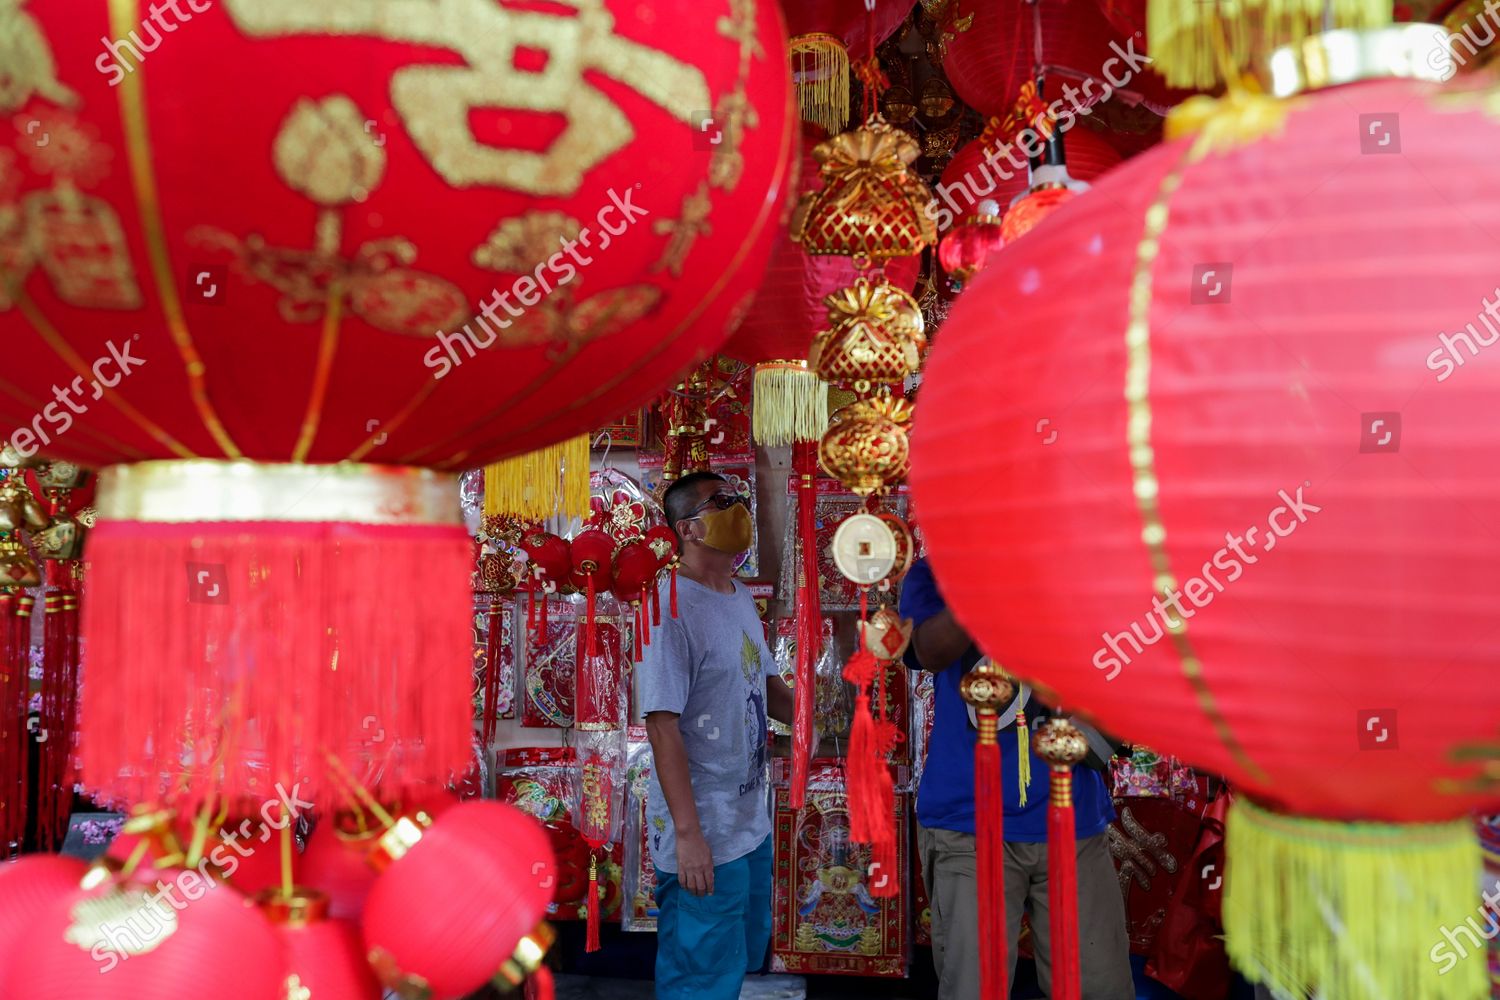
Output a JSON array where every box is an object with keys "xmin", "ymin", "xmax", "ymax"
[{"xmin": 636, "ymin": 472, "xmax": 792, "ymax": 1000}]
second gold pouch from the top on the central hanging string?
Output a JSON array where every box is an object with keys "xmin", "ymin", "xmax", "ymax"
[{"xmin": 807, "ymin": 277, "xmax": 927, "ymax": 396}]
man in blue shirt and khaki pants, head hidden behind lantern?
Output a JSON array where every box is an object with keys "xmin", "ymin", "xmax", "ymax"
[{"xmin": 900, "ymin": 559, "xmax": 1136, "ymax": 1000}]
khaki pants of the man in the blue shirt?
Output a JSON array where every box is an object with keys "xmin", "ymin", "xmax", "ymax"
[{"xmin": 917, "ymin": 826, "xmax": 1136, "ymax": 1000}]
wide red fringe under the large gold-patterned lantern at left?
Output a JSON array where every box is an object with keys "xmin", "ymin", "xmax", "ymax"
[{"xmin": 78, "ymin": 520, "xmax": 474, "ymax": 811}]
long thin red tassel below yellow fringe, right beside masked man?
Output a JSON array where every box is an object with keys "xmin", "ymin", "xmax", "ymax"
[{"xmin": 788, "ymin": 441, "xmax": 824, "ymax": 810}]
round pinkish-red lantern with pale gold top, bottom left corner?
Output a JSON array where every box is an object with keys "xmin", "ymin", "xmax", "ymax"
[{"xmin": 0, "ymin": 868, "xmax": 285, "ymax": 1000}]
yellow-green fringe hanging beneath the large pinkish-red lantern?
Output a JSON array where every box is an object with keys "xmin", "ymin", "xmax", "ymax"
[{"xmin": 1205, "ymin": 801, "xmax": 1491, "ymax": 1000}]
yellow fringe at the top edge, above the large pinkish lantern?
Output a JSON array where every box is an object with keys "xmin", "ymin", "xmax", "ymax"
[{"xmin": 1146, "ymin": 0, "xmax": 1391, "ymax": 90}]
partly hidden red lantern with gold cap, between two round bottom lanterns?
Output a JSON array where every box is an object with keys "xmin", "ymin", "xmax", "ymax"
[{"xmin": 257, "ymin": 889, "xmax": 384, "ymax": 1000}]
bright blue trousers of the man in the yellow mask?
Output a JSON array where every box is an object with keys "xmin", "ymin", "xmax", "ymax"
[{"xmin": 656, "ymin": 837, "xmax": 771, "ymax": 1000}]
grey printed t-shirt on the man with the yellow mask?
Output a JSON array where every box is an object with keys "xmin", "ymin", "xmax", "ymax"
[{"xmin": 636, "ymin": 576, "xmax": 776, "ymax": 874}]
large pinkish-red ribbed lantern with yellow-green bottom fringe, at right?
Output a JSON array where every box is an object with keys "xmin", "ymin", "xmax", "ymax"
[{"xmin": 912, "ymin": 57, "xmax": 1500, "ymax": 997}]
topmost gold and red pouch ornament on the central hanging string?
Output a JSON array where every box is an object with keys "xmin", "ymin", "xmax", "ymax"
[{"xmin": 792, "ymin": 114, "xmax": 938, "ymax": 261}]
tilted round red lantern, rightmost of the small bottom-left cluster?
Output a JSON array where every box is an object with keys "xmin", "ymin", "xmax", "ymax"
[{"xmin": 365, "ymin": 801, "xmax": 555, "ymax": 1000}]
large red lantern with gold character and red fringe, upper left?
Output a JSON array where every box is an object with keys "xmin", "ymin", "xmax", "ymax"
[{"xmin": 0, "ymin": 0, "xmax": 794, "ymax": 805}]
